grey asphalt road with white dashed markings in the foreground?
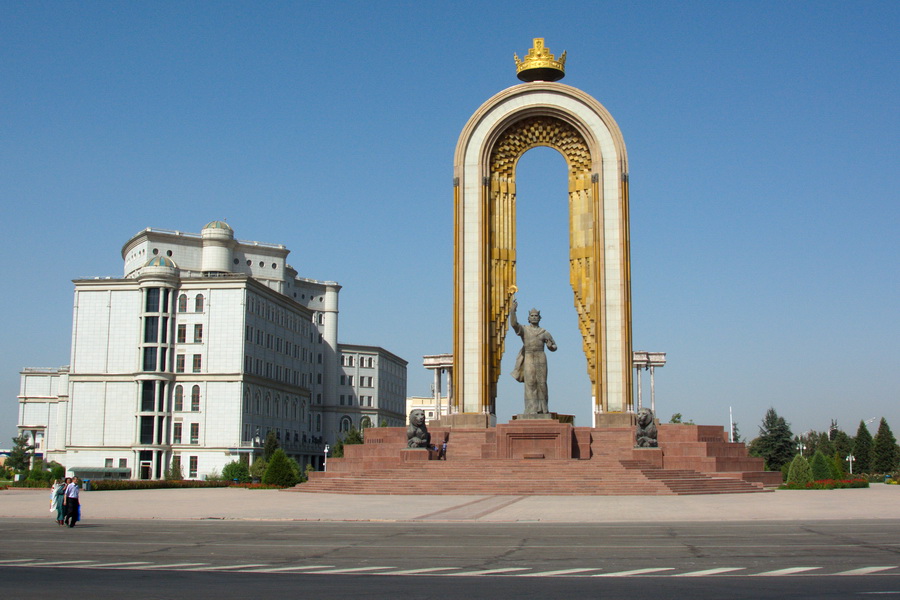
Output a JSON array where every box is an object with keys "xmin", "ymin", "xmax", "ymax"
[{"xmin": 0, "ymin": 519, "xmax": 900, "ymax": 600}]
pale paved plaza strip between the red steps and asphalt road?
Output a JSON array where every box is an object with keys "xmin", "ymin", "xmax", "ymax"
[{"xmin": 0, "ymin": 484, "xmax": 900, "ymax": 523}]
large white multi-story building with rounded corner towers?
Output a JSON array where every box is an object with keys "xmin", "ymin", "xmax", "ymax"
[{"xmin": 19, "ymin": 221, "xmax": 406, "ymax": 479}]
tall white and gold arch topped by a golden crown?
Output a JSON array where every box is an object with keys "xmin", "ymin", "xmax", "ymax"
[{"xmin": 453, "ymin": 38, "xmax": 632, "ymax": 427}]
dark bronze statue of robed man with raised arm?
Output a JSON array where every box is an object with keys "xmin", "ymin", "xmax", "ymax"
[{"xmin": 509, "ymin": 300, "xmax": 556, "ymax": 415}]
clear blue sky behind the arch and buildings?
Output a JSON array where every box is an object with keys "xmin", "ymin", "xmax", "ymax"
[{"xmin": 0, "ymin": 0, "xmax": 900, "ymax": 447}]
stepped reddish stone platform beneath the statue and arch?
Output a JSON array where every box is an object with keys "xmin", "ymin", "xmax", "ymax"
[{"xmin": 294, "ymin": 415, "xmax": 781, "ymax": 496}]
